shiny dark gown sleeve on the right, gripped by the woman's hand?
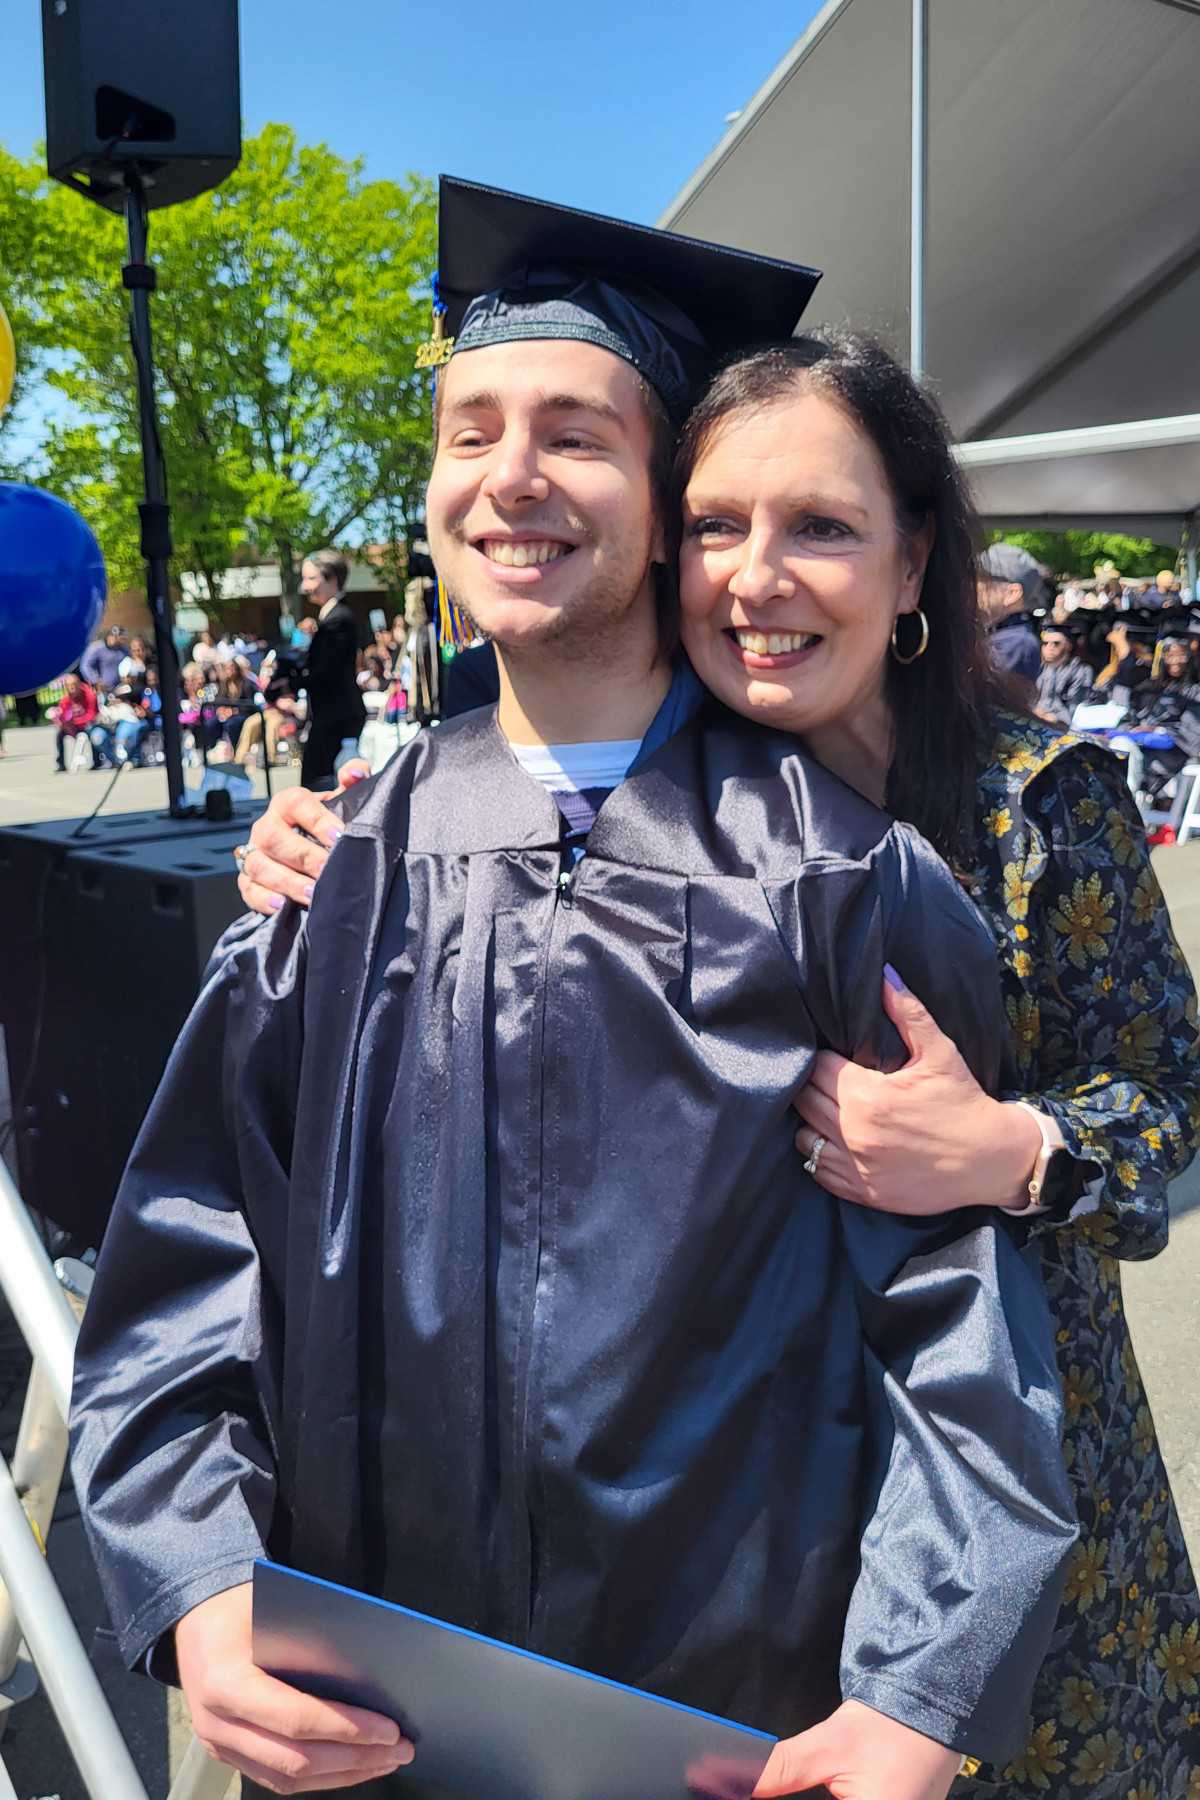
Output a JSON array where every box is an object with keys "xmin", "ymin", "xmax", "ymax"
[{"xmin": 798, "ymin": 826, "xmax": 1076, "ymax": 1760}]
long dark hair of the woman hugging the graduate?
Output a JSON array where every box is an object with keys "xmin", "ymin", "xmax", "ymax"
[{"xmin": 667, "ymin": 329, "xmax": 1020, "ymax": 875}]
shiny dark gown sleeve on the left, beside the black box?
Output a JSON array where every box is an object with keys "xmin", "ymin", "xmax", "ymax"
[{"xmin": 72, "ymin": 905, "xmax": 306, "ymax": 1676}]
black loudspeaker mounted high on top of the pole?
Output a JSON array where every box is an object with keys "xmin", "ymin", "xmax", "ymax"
[{"xmin": 41, "ymin": 0, "xmax": 241, "ymax": 212}]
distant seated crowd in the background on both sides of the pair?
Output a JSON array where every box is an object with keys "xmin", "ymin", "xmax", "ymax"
[{"xmin": 35, "ymin": 544, "xmax": 1200, "ymax": 801}]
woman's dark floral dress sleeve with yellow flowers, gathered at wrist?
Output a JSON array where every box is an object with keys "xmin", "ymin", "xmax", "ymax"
[{"xmin": 1004, "ymin": 747, "xmax": 1200, "ymax": 1258}]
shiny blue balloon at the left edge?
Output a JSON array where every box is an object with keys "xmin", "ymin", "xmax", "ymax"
[{"xmin": 0, "ymin": 481, "xmax": 108, "ymax": 693}]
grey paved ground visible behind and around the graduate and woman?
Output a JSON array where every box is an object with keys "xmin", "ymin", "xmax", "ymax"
[{"xmin": 0, "ymin": 727, "xmax": 1200, "ymax": 1800}]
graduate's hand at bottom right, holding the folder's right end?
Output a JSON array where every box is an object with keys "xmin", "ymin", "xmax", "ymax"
[{"xmin": 754, "ymin": 1699, "xmax": 963, "ymax": 1800}]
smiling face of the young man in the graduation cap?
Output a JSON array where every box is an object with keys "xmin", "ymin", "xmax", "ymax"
[{"xmin": 426, "ymin": 340, "xmax": 664, "ymax": 650}]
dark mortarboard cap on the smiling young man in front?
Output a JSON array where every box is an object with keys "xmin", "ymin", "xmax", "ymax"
[{"xmin": 437, "ymin": 175, "xmax": 820, "ymax": 423}]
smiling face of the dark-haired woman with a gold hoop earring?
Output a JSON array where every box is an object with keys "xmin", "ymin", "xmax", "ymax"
[{"xmin": 680, "ymin": 387, "xmax": 930, "ymax": 733}]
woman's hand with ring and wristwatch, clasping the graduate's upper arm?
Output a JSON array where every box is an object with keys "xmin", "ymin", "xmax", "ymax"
[{"xmin": 793, "ymin": 983, "xmax": 1042, "ymax": 1213}]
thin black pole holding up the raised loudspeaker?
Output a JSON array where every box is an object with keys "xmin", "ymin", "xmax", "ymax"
[{"xmin": 121, "ymin": 169, "xmax": 191, "ymax": 819}]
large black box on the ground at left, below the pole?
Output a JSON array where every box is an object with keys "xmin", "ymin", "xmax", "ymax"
[{"xmin": 0, "ymin": 805, "xmax": 263, "ymax": 1244}]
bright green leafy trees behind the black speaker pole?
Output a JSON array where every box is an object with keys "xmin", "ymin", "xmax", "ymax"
[{"xmin": 0, "ymin": 126, "xmax": 435, "ymax": 610}]
